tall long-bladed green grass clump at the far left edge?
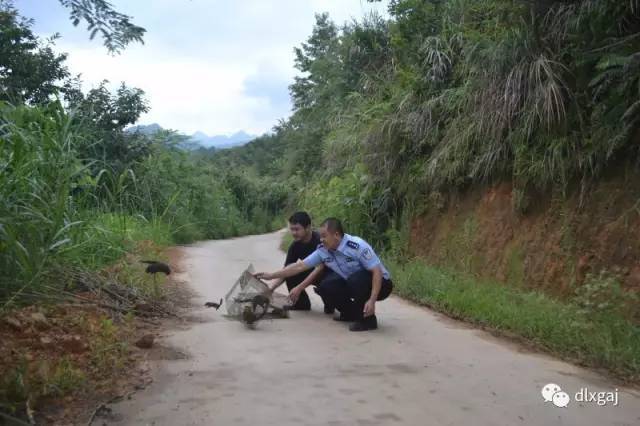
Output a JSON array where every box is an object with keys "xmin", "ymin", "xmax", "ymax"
[{"xmin": 0, "ymin": 105, "xmax": 84, "ymax": 299}]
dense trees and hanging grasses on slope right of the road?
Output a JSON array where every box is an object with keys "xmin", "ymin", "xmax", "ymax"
[{"xmin": 218, "ymin": 0, "xmax": 640, "ymax": 246}]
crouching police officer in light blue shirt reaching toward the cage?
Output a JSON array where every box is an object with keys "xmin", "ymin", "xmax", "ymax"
[{"xmin": 256, "ymin": 218, "xmax": 393, "ymax": 331}]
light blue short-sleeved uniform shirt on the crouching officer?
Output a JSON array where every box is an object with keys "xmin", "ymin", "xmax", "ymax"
[{"xmin": 303, "ymin": 234, "xmax": 391, "ymax": 280}]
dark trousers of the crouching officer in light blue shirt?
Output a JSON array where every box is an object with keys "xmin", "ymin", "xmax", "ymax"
[{"xmin": 318, "ymin": 270, "xmax": 393, "ymax": 320}]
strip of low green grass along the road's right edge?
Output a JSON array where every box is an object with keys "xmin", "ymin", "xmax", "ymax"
[{"xmin": 388, "ymin": 260, "xmax": 640, "ymax": 382}]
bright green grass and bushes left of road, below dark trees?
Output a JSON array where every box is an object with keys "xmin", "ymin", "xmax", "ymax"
[{"xmin": 0, "ymin": 103, "xmax": 278, "ymax": 310}]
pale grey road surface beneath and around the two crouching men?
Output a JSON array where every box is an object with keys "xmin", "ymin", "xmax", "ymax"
[{"xmin": 104, "ymin": 233, "xmax": 640, "ymax": 426}]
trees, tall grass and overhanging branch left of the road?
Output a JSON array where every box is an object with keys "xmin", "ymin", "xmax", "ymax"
[{"xmin": 0, "ymin": 1, "xmax": 282, "ymax": 307}]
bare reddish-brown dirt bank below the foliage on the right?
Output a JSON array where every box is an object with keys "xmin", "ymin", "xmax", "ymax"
[{"xmin": 411, "ymin": 170, "xmax": 640, "ymax": 296}]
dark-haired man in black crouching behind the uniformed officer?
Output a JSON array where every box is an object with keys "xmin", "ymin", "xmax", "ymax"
[{"xmin": 271, "ymin": 212, "xmax": 333, "ymax": 313}]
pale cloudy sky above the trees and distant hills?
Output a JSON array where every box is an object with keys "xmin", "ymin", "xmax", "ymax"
[{"xmin": 14, "ymin": 0, "xmax": 387, "ymax": 135}]
